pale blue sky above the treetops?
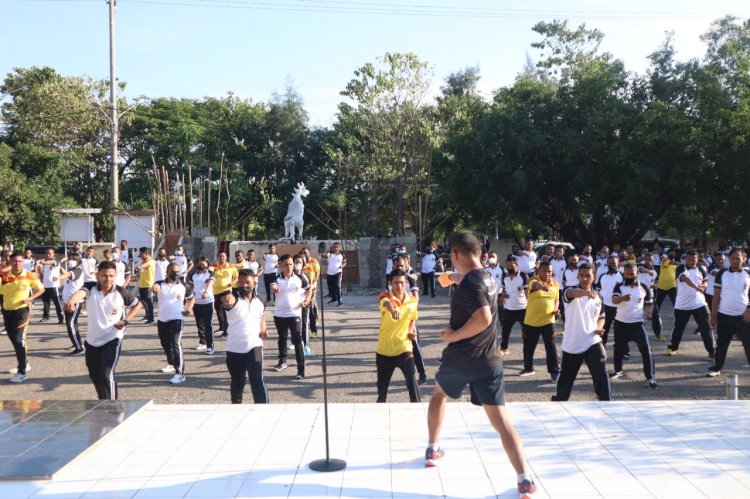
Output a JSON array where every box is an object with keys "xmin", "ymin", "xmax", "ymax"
[{"xmin": 0, "ymin": 0, "xmax": 750, "ymax": 126}]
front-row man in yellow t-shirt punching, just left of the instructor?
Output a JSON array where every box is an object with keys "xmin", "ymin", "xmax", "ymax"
[{"xmin": 375, "ymin": 269, "xmax": 420, "ymax": 402}]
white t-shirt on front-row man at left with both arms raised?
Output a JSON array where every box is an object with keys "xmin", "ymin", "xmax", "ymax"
[{"xmin": 81, "ymin": 282, "xmax": 138, "ymax": 347}]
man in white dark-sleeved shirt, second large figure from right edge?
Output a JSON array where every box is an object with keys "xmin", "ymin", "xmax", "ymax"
[{"xmin": 667, "ymin": 250, "xmax": 716, "ymax": 362}]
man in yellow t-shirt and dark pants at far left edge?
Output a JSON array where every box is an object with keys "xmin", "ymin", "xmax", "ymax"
[{"xmin": 0, "ymin": 253, "xmax": 44, "ymax": 383}]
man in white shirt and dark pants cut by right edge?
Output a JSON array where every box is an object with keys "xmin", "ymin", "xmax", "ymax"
[{"xmin": 708, "ymin": 248, "xmax": 750, "ymax": 376}]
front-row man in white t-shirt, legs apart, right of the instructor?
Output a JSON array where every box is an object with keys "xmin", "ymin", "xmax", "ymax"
[{"xmin": 552, "ymin": 262, "xmax": 612, "ymax": 402}]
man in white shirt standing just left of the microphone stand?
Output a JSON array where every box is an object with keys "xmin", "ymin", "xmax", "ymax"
[{"xmin": 271, "ymin": 255, "xmax": 311, "ymax": 380}]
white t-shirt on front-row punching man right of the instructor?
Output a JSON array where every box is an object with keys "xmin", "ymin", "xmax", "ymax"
[{"xmin": 562, "ymin": 287, "xmax": 604, "ymax": 354}]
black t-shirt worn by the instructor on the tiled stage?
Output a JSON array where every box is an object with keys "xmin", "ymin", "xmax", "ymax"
[{"xmin": 441, "ymin": 269, "xmax": 503, "ymax": 369}]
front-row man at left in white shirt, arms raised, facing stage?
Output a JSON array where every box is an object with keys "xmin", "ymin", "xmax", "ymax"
[{"xmin": 65, "ymin": 262, "xmax": 141, "ymax": 400}]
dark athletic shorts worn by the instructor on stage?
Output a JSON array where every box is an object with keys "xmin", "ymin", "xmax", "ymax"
[{"xmin": 435, "ymin": 364, "xmax": 505, "ymax": 405}]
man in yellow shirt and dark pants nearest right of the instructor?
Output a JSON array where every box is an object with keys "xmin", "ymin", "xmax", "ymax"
[{"xmin": 518, "ymin": 262, "xmax": 560, "ymax": 383}]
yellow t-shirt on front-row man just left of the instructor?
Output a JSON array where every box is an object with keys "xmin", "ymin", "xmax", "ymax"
[{"xmin": 375, "ymin": 292, "xmax": 418, "ymax": 357}]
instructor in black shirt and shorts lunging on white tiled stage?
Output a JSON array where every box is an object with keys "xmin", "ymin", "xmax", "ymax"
[{"xmin": 425, "ymin": 232, "xmax": 536, "ymax": 499}]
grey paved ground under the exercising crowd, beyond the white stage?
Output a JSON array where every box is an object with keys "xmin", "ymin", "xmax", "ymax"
[{"xmin": 0, "ymin": 292, "xmax": 750, "ymax": 404}]
